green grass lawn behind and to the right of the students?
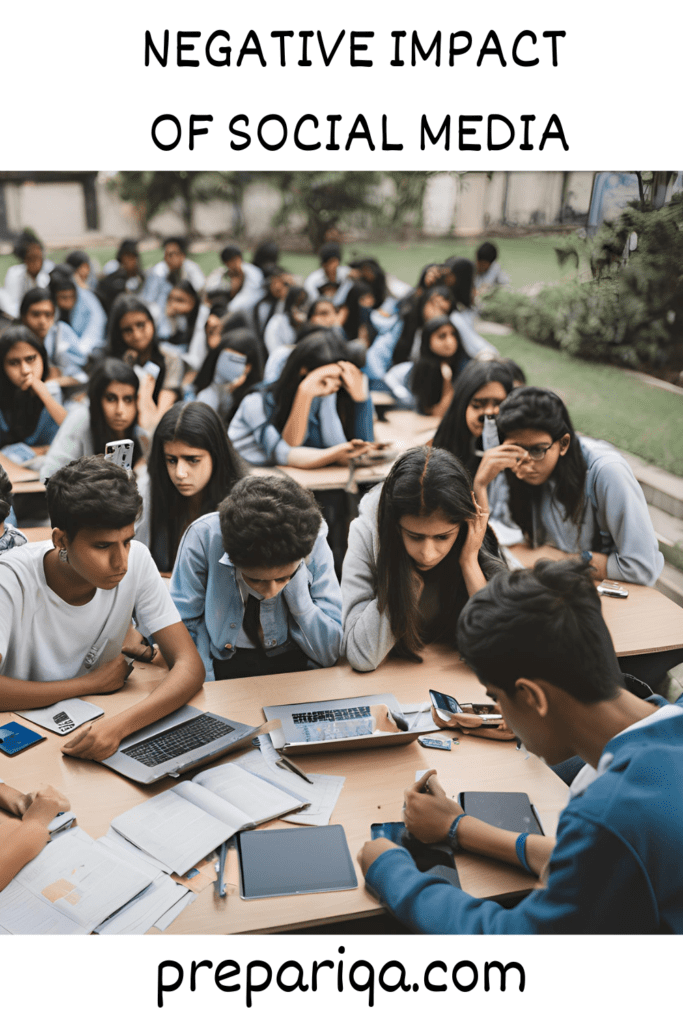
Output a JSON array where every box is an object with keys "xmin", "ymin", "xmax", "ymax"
[{"xmin": 0, "ymin": 234, "xmax": 683, "ymax": 476}]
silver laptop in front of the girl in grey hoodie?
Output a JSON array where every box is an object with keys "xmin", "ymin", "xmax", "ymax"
[{"xmin": 263, "ymin": 693, "xmax": 420, "ymax": 754}]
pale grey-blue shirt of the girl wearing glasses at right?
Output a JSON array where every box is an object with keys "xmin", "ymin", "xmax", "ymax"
[{"xmin": 532, "ymin": 437, "xmax": 664, "ymax": 587}]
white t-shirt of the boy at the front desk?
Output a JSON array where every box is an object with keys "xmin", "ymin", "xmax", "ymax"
[{"xmin": 0, "ymin": 541, "xmax": 180, "ymax": 682}]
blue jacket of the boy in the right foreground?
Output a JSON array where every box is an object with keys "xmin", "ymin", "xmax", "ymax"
[{"xmin": 366, "ymin": 698, "xmax": 683, "ymax": 935}]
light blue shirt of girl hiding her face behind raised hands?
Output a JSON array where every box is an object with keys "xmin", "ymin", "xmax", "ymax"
[{"xmin": 227, "ymin": 391, "xmax": 374, "ymax": 466}]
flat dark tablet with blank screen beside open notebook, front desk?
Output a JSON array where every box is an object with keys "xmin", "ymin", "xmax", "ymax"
[{"xmin": 237, "ymin": 825, "xmax": 358, "ymax": 899}]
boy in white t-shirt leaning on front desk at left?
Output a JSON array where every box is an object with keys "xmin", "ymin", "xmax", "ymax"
[{"xmin": 0, "ymin": 456, "xmax": 204, "ymax": 761}]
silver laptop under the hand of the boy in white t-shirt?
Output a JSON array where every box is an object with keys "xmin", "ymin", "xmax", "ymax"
[{"xmin": 102, "ymin": 705, "xmax": 263, "ymax": 785}]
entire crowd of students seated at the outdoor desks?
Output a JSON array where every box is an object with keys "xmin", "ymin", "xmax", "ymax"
[{"xmin": 0, "ymin": 230, "xmax": 683, "ymax": 932}]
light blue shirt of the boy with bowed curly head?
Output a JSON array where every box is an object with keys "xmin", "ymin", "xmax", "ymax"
[{"xmin": 171, "ymin": 512, "xmax": 342, "ymax": 680}]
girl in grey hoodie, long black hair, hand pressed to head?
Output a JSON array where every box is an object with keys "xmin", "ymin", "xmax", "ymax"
[{"xmin": 342, "ymin": 446, "xmax": 505, "ymax": 672}]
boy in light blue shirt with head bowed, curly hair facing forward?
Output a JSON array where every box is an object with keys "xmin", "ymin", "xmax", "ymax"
[{"xmin": 171, "ymin": 476, "xmax": 341, "ymax": 679}]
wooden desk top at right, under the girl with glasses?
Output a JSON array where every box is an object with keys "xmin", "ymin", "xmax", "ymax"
[{"xmin": 510, "ymin": 544, "xmax": 683, "ymax": 657}]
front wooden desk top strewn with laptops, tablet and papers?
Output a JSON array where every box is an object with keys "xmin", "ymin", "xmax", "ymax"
[{"xmin": 0, "ymin": 648, "xmax": 567, "ymax": 934}]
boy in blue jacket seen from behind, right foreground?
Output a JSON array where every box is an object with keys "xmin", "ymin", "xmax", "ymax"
[{"xmin": 359, "ymin": 561, "xmax": 683, "ymax": 934}]
